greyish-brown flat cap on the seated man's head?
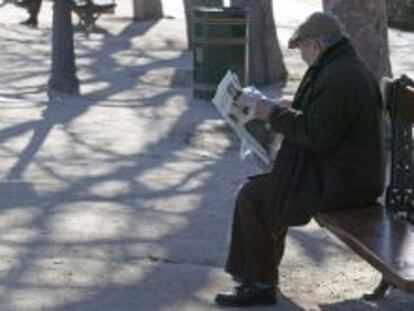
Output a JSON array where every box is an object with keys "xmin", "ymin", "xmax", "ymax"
[{"xmin": 288, "ymin": 12, "xmax": 342, "ymax": 49}]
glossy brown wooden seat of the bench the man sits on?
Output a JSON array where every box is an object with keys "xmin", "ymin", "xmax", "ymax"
[{"xmin": 315, "ymin": 205, "xmax": 414, "ymax": 293}]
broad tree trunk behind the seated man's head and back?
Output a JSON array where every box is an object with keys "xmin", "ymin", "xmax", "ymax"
[{"xmin": 323, "ymin": 0, "xmax": 391, "ymax": 79}]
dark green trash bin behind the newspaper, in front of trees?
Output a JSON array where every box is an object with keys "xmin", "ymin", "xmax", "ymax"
[{"xmin": 193, "ymin": 7, "xmax": 248, "ymax": 100}]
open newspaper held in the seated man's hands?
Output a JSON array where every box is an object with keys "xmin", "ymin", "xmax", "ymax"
[{"xmin": 213, "ymin": 71, "xmax": 281, "ymax": 167}]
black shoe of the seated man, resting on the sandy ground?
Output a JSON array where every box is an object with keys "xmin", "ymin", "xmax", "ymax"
[{"xmin": 215, "ymin": 283, "xmax": 277, "ymax": 307}]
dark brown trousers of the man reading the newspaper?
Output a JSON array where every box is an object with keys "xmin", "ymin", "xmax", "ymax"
[{"xmin": 225, "ymin": 178, "xmax": 288, "ymax": 288}]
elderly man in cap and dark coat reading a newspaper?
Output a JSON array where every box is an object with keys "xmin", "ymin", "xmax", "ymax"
[{"xmin": 215, "ymin": 12, "xmax": 384, "ymax": 307}]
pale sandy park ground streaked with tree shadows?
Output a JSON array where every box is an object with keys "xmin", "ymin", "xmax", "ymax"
[{"xmin": 0, "ymin": 0, "xmax": 414, "ymax": 311}]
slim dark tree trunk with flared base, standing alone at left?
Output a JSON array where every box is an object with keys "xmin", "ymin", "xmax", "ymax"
[{"xmin": 48, "ymin": 0, "xmax": 79, "ymax": 97}]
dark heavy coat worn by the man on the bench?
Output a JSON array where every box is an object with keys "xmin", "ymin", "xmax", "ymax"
[{"xmin": 257, "ymin": 38, "xmax": 385, "ymax": 225}]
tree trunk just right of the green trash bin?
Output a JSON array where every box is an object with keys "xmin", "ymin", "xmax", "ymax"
[{"xmin": 231, "ymin": 0, "xmax": 287, "ymax": 86}]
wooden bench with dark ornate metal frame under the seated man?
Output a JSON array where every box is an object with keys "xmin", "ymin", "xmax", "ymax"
[{"xmin": 315, "ymin": 77, "xmax": 414, "ymax": 300}]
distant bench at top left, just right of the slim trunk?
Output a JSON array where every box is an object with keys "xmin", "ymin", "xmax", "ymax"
[{"xmin": 72, "ymin": 0, "xmax": 116, "ymax": 30}]
